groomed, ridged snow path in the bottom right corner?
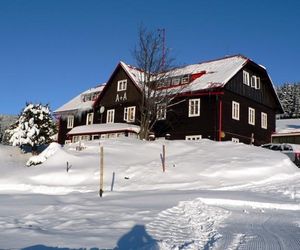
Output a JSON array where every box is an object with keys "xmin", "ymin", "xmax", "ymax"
[{"xmin": 213, "ymin": 209, "xmax": 300, "ymax": 250}]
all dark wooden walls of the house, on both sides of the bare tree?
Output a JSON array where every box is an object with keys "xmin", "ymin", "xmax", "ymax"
[{"xmin": 55, "ymin": 54, "xmax": 282, "ymax": 145}]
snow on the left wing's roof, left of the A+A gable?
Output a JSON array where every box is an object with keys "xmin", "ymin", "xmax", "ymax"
[{"xmin": 54, "ymin": 83, "xmax": 105, "ymax": 113}]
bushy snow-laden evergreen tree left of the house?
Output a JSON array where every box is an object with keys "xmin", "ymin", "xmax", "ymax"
[{"xmin": 7, "ymin": 103, "xmax": 56, "ymax": 153}]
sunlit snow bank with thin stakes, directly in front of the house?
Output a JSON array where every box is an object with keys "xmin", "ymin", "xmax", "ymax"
[{"xmin": 3, "ymin": 138, "xmax": 299, "ymax": 194}]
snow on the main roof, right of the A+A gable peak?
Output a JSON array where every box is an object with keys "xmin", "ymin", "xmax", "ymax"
[{"xmin": 120, "ymin": 55, "xmax": 248, "ymax": 92}]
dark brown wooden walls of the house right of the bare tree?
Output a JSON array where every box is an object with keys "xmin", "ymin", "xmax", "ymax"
[{"xmin": 155, "ymin": 62, "xmax": 281, "ymax": 145}]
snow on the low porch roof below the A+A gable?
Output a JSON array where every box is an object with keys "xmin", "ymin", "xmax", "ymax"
[{"xmin": 68, "ymin": 123, "xmax": 140, "ymax": 135}]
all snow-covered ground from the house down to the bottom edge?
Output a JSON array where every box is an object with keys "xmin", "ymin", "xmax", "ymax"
[{"xmin": 0, "ymin": 138, "xmax": 300, "ymax": 250}]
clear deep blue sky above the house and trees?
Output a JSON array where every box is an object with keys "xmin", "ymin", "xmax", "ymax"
[{"xmin": 0, "ymin": 0, "xmax": 300, "ymax": 114}]
